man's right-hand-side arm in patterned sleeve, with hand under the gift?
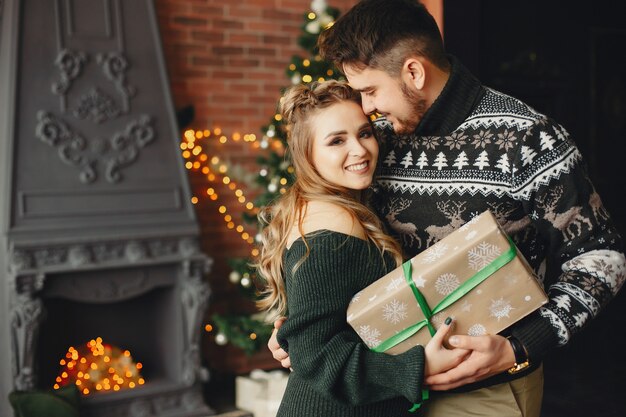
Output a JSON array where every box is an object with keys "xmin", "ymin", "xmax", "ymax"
[{"xmin": 425, "ymin": 115, "xmax": 626, "ymax": 390}]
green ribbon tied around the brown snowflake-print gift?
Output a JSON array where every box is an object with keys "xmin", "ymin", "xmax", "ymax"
[{"xmin": 372, "ymin": 236, "xmax": 517, "ymax": 352}]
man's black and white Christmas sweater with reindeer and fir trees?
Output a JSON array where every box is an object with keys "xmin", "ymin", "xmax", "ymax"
[{"xmin": 372, "ymin": 57, "xmax": 626, "ymax": 376}]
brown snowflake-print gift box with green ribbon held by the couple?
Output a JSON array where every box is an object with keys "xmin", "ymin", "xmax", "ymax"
[{"xmin": 347, "ymin": 211, "xmax": 548, "ymax": 354}]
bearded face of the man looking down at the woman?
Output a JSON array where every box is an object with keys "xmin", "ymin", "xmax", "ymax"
[{"xmin": 343, "ymin": 65, "xmax": 426, "ymax": 135}]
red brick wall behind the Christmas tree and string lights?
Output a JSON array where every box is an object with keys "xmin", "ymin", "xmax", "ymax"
[{"xmin": 155, "ymin": 0, "xmax": 356, "ymax": 368}]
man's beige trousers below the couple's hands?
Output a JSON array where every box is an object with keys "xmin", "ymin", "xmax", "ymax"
[{"xmin": 420, "ymin": 365, "xmax": 543, "ymax": 417}]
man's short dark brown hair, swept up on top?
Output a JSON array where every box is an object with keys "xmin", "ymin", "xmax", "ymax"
[{"xmin": 318, "ymin": 0, "xmax": 450, "ymax": 76}]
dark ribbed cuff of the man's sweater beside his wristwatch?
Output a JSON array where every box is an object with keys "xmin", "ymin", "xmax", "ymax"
[{"xmin": 511, "ymin": 311, "xmax": 559, "ymax": 362}]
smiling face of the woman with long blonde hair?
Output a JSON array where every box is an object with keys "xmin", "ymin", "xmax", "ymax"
[{"xmin": 309, "ymin": 101, "xmax": 378, "ymax": 190}]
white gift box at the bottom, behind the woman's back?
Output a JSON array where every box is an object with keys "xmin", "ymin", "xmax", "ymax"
[{"xmin": 235, "ymin": 369, "xmax": 289, "ymax": 417}]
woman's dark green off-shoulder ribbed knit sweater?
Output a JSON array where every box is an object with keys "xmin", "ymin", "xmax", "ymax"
[{"xmin": 278, "ymin": 230, "xmax": 424, "ymax": 417}]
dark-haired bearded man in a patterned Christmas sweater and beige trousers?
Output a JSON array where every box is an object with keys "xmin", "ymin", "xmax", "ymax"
[{"xmin": 269, "ymin": 0, "xmax": 626, "ymax": 416}]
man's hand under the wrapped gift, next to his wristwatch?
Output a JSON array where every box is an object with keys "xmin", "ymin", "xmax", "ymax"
[{"xmin": 424, "ymin": 335, "xmax": 515, "ymax": 391}]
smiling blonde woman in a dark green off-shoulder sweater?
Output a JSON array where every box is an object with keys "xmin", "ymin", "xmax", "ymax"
[{"xmin": 257, "ymin": 81, "xmax": 466, "ymax": 417}]
